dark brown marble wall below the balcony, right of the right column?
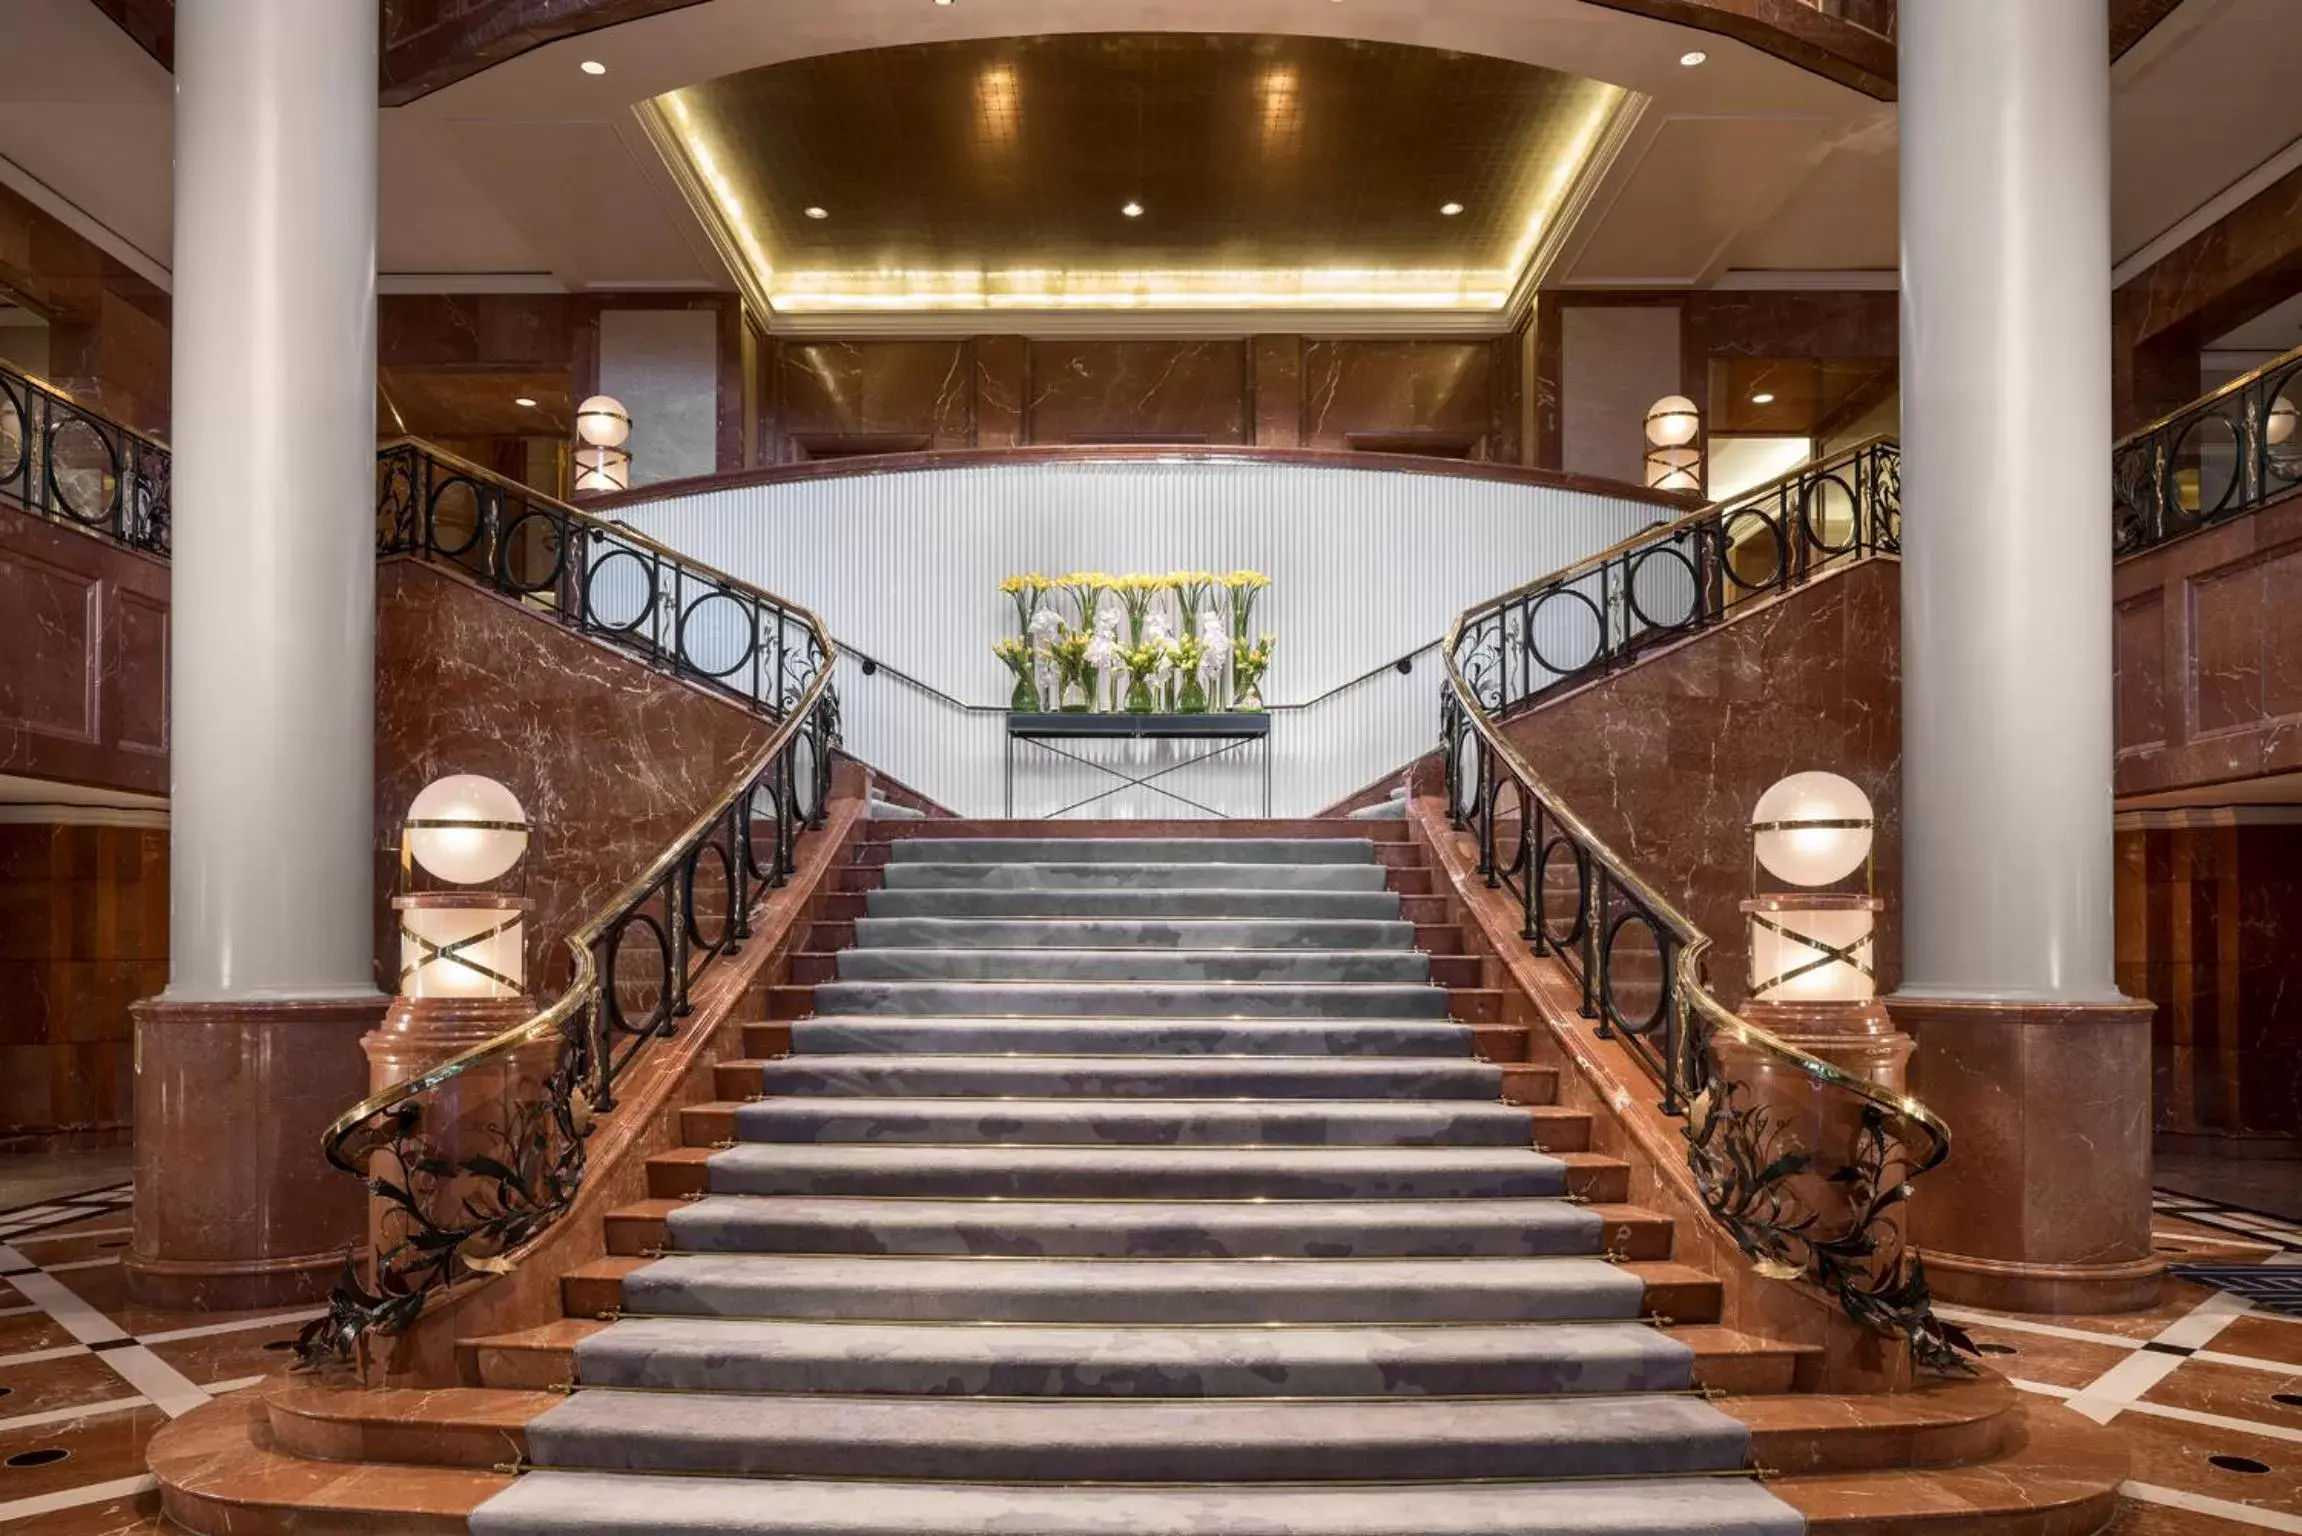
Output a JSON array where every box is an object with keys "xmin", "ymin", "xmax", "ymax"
[{"xmin": 2118, "ymin": 806, "xmax": 2302, "ymax": 1156}]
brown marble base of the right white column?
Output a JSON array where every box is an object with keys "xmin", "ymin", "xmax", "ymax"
[{"xmin": 1888, "ymin": 997, "xmax": 2166, "ymax": 1313}]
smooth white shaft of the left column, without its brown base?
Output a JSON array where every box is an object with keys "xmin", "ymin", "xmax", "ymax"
[{"xmin": 168, "ymin": 0, "xmax": 380, "ymax": 1002}]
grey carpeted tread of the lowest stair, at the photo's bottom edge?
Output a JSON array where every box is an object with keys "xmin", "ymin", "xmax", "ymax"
[{"xmin": 472, "ymin": 1472, "xmax": 1807, "ymax": 1536}]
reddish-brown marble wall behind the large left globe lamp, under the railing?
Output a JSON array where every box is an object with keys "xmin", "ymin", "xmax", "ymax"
[{"xmin": 375, "ymin": 560, "xmax": 769, "ymax": 997}]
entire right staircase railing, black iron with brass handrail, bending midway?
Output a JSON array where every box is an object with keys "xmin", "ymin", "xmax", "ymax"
[{"xmin": 1441, "ymin": 444, "xmax": 1968, "ymax": 1370}]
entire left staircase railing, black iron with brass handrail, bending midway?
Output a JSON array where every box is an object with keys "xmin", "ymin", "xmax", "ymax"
[{"xmin": 299, "ymin": 444, "xmax": 838, "ymax": 1363}]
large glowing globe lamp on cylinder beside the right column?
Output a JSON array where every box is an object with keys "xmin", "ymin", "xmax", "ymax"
[{"xmin": 1743, "ymin": 774, "xmax": 1885, "ymax": 1004}]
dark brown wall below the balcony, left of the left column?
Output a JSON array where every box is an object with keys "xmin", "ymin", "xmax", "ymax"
[{"xmin": 0, "ymin": 822, "xmax": 168, "ymax": 1151}]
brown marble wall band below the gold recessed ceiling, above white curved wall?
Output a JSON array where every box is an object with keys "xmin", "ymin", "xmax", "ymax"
[{"xmin": 753, "ymin": 336, "xmax": 1522, "ymax": 463}]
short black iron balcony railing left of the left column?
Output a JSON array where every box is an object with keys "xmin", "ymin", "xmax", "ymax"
[{"xmin": 0, "ymin": 364, "xmax": 168, "ymax": 557}]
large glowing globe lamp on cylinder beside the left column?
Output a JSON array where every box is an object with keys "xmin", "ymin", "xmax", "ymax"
[{"xmin": 391, "ymin": 774, "xmax": 529, "ymax": 999}]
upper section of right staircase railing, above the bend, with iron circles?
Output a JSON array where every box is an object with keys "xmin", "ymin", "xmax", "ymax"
[{"xmin": 1448, "ymin": 438, "xmax": 1901, "ymax": 714}]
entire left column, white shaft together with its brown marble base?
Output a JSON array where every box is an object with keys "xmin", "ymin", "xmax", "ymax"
[{"xmin": 129, "ymin": 0, "xmax": 384, "ymax": 1306}]
